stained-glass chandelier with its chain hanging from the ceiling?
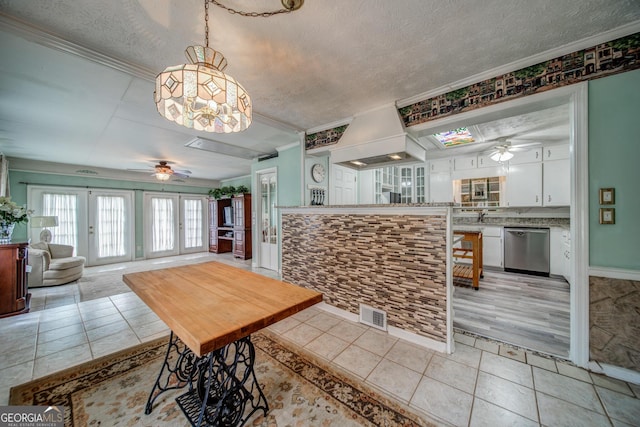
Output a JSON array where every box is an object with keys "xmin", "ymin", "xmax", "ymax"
[{"xmin": 154, "ymin": 0, "xmax": 304, "ymax": 134}]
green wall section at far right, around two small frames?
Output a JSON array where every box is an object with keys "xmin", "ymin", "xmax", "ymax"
[{"xmin": 589, "ymin": 70, "xmax": 640, "ymax": 270}]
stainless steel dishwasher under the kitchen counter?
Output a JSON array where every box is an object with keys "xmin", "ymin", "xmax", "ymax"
[{"xmin": 504, "ymin": 227, "xmax": 549, "ymax": 276}]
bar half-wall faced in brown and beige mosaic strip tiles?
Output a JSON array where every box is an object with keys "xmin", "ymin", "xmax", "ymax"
[{"xmin": 282, "ymin": 209, "xmax": 447, "ymax": 342}]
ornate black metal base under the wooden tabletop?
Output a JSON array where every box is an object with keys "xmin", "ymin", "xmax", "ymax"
[{"xmin": 145, "ymin": 332, "xmax": 269, "ymax": 427}]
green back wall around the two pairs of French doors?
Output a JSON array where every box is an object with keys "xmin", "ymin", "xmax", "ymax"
[{"xmin": 9, "ymin": 170, "xmax": 209, "ymax": 258}]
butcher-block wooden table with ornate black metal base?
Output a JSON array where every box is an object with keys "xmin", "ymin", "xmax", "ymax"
[{"xmin": 123, "ymin": 262, "xmax": 322, "ymax": 427}]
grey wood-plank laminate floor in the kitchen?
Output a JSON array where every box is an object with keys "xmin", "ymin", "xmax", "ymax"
[{"xmin": 453, "ymin": 270, "xmax": 569, "ymax": 358}]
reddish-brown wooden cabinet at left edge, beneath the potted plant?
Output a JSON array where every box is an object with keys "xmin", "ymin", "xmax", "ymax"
[{"xmin": 0, "ymin": 242, "xmax": 31, "ymax": 317}]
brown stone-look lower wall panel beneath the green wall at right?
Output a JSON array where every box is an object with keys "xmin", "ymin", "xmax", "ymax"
[{"xmin": 589, "ymin": 276, "xmax": 640, "ymax": 372}]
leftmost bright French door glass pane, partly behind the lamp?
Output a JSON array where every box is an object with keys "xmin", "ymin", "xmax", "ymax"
[{"xmin": 42, "ymin": 193, "xmax": 78, "ymax": 251}]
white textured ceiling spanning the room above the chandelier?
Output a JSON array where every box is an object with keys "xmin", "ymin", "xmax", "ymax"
[{"xmin": 0, "ymin": 0, "xmax": 640, "ymax": 179}]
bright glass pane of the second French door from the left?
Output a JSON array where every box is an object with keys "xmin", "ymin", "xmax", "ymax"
[{"xmin": 95, "ymin": 196, "xmax": 126, "ymax": 258}]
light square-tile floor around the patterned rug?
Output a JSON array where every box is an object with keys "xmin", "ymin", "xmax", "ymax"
[{"xmin": 0, "ymin": 256, "xmax": 640, "ymax": 426}]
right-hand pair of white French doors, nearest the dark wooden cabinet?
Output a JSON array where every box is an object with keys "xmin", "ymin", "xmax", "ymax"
[{"xmin": 144, "ymin": 193, "xmax": 208, "ymax": 258}]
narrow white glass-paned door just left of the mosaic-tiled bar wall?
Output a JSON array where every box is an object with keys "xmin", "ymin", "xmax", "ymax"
[{"xmin": 257, "ymin": 170, "xmax": 278, "ymax": 271}]
